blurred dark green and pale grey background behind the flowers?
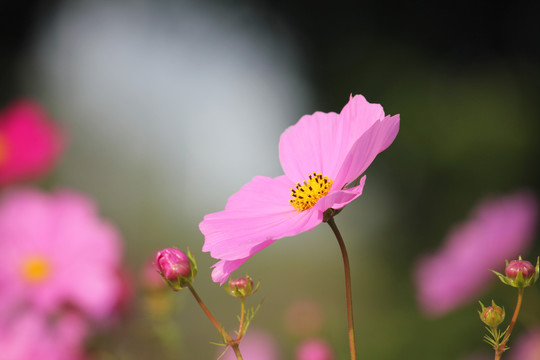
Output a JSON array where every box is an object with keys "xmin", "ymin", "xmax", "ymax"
[{"xmin": 0, "ymin": 0, "xmax": 540, "ymax": 359}]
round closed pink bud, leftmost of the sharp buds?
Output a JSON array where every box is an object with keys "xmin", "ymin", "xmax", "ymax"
[{"xmin": 156, "ymin": 248, "xmax": 197, "ymax": 291}]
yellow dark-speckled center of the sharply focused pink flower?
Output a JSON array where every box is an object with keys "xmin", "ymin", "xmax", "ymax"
[{"xmin": 289, "ymin": 172, "xmax": 333, "ymax": 212}]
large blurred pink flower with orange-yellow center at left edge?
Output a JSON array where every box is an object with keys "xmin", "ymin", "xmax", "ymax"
[{"xmin": 0, "ymin": 189, "xmax": 124, "ymax": 320}]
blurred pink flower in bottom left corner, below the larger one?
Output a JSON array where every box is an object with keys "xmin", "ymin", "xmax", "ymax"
[{"xmin": 0, "ymin": 312, "xmax": 88, "ymax": 360}]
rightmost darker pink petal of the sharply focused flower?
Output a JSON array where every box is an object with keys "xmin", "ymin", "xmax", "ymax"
[{"xmin": 332, "ymin": 115, "xmax": 399, "ymax": 188}]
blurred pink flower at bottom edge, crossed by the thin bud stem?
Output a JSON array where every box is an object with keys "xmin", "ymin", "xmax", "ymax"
[{"xmin": 220, "ymin": 329, "xmax": 281, "ymax": 360}]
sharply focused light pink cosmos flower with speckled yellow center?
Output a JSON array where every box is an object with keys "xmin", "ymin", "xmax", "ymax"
[{"xmin": 199, "ymin": 95, "xmax": 399, "ymax": 284}]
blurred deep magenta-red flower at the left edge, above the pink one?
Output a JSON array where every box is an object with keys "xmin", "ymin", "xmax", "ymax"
[{"xmin": 0, "ymin": 100, "xmax": 63, "ymax": 186}]
